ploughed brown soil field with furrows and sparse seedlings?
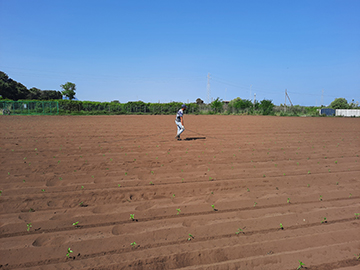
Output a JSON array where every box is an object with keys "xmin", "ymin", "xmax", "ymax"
[{"xmin": 0, "ymin": 115, "xmax": 360, "ymax": 270}]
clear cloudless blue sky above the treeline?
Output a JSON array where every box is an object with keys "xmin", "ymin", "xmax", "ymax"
[{"xmin": 0, "ymin": 0, "xmax": 360, "ymax": 106}]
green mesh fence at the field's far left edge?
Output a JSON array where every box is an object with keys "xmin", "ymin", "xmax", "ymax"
[{"xmin": 0, "ymin": 101, "xmax": 59, "ymax": 115}]
